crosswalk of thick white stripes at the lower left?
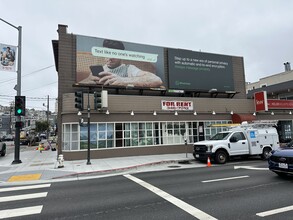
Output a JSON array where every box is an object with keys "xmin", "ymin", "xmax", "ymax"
[{"xmin": 0, "ymin": 184, "xmax": 51, "ymax": 219}]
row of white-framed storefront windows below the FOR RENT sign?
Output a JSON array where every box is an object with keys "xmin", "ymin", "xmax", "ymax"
[{"xmin": 62, "ymin": 121, "xmax": 231, "ymax": 151}]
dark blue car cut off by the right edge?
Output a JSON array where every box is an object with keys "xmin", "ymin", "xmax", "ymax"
[{"xmin": 268, "ymin": 141, "xmax": 293, "ymax": 176}]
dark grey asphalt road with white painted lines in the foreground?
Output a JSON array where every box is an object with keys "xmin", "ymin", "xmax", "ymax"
[{"xmin": 0, "ymin": 160, "xmax": 293, "ymax": 220}]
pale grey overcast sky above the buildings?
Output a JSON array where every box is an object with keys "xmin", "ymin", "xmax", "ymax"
[{"xmin": 0, "ymin": 0, "xmax": 293, "ymax": 111}]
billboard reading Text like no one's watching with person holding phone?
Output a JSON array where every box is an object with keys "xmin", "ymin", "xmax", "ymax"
[{"xmin": 76, "ymin": 35, "xmax": 167, "ymax": 88}]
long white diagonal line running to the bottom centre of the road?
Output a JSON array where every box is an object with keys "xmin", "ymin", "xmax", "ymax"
[{"xmin": 124, "ymin": 174, "xmax": 217, "ymax": 220}]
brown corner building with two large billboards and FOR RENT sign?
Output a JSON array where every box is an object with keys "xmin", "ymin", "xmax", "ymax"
[{"xmin": 53, "ymin": 25, "xmax": 292, "ymax": 160}]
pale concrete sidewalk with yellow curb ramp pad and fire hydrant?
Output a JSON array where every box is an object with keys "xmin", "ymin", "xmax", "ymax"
[{"xmin": 0, "ymin": 144, "xmax": 201, "ymax": 184}]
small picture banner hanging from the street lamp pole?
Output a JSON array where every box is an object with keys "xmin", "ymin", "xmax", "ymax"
[{"xmin": 0, "ymin": 44, "xmax": 16, "ymax": 72}]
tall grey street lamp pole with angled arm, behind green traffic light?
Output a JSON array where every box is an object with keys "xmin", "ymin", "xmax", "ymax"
[{"xmin": 0, "ymin": 18, "xmax": 22, "ymax": 164}]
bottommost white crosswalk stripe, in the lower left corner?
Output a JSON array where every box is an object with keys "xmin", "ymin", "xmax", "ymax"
[{"xmin": 0, "ymin": 205, "xmax": 43, "ymax": 219}]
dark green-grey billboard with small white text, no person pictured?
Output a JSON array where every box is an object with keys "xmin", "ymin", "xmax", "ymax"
[{"xmin": 168, "ymin": 49, "xmax": 234, "ymax": 92}]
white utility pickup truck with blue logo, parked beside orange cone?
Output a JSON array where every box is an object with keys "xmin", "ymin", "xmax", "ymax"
[{"xmin": 193, "ymin": 126, "xmax": 279, "ymax": 164}]
